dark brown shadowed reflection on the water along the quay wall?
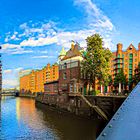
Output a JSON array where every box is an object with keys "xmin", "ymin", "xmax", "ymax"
[{"xmin": 36, "ymin": 104, "xmax": 102, "ymax": 140}]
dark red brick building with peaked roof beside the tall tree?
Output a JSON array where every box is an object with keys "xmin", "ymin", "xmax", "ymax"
[{"xmin": 59, "ymin": 42, "xmax": 83, "ymax": 93}]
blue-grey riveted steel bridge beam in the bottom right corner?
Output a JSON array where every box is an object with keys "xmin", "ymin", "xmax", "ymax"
[{"xmin": 97, "ymin": 82, "xmax": 140, "ymax": 140}]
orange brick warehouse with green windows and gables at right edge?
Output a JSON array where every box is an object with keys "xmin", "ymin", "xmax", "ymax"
[{"xmin": 110, "ymin": 43, "xmax": 140, "ymax": 88}]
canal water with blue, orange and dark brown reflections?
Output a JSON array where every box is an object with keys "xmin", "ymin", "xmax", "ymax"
[{"xmin": 0, "ymin": 97, "xmax": 104, "ymax": 140}]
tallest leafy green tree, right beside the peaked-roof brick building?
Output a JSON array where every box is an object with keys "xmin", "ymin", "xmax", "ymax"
[{"xmin": 82, "ymin": 34, "xmax": 112, "ymax": 93}]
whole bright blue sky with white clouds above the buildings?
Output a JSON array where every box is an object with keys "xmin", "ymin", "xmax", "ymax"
[{"xmin": 0, "ymin": 0, "xmax": 140, "ymax": 88}]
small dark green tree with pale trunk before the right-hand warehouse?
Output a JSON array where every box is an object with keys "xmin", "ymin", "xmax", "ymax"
[{"xmin": 114, "ymin": 69, "xmax": 127, "ymax": 92}]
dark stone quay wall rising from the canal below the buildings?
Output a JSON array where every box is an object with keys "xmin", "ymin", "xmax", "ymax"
[{"xmin": 36, "ymin": 94, "xmax": 126, "ymax": 118}]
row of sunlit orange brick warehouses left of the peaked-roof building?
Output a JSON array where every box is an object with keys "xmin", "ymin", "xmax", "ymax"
[{"xmin": 20, "ymin": 63, "xmax": 59, "ymax": 94}]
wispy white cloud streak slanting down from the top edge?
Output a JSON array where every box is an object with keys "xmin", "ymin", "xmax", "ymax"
[{"xmin": 74, "ymin": 0, "xmax": 115, "ymax": 49}]
